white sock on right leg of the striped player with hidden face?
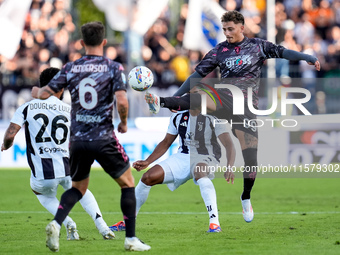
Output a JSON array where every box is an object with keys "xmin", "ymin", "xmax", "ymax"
[{"xmin": 197, "ymin": 177, "xmax": 220, "ymax": 225}]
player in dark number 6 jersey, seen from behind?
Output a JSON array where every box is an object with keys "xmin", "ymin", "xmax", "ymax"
[{"xmin": 32, "ymin": 22, "xmax": 151, "ymax": 251}]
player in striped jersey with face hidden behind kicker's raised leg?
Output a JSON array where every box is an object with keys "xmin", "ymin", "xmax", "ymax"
[{"xmin": 133, "ymin": 100, "xmax": 235, "ymax": 232}]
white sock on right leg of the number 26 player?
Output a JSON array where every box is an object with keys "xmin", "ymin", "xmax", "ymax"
[{"xmin": 79, "ymin": 190, "xmax": 108, "ymax": 232}]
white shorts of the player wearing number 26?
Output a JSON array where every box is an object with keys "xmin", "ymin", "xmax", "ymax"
[{"xmin": 30, "ymin": 176, "xmax": 72, "ymax": 197}]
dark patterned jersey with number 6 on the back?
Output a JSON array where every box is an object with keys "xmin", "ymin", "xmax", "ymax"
[{"xmin": 48, "ymin": 55, "xmax": 126, "ymax": 141}]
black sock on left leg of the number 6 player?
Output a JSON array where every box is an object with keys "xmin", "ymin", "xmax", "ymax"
[{"xmin": 54, "ymin": 187, "xmax": 83, "ymax": 225}]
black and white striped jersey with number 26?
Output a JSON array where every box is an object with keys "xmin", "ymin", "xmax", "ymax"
[{"xmin": 11, "ymin": 96, "xmax": 71, "ymax": 180}]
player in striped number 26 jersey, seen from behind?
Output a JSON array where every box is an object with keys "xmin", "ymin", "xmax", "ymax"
[{"xmin": 1, "ymin": 67, "xmax": 115, "ymax": 243}]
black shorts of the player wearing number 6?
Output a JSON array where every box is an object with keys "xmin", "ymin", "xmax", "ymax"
[{"xmin": 70, "ymin": 138, "xmax": 130, "ymax": 181}]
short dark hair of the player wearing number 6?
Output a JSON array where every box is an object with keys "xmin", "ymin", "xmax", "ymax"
[{"xmin": 81, "ymin": 21, "xmax": 105, "ymax": 46}]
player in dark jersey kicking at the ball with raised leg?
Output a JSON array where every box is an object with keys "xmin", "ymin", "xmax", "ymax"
[{"xmin": 146, "ymin": 11, "xmax": 320, "ymax": 222}]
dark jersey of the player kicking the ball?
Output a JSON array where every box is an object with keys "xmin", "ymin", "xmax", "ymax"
[{"xmin": 196, "ymin": 37, "xmax": 285, "ymax": 106}]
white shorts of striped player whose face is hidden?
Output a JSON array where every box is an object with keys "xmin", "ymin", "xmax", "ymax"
[{"xmin": 158, "ymin": 153, "xmax": 218, "ymax": 191}]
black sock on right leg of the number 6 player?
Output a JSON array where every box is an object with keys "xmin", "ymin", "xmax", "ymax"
[{"xmin": 120, "ymin": 188, "xmax": 136, "ymax": 237}]
